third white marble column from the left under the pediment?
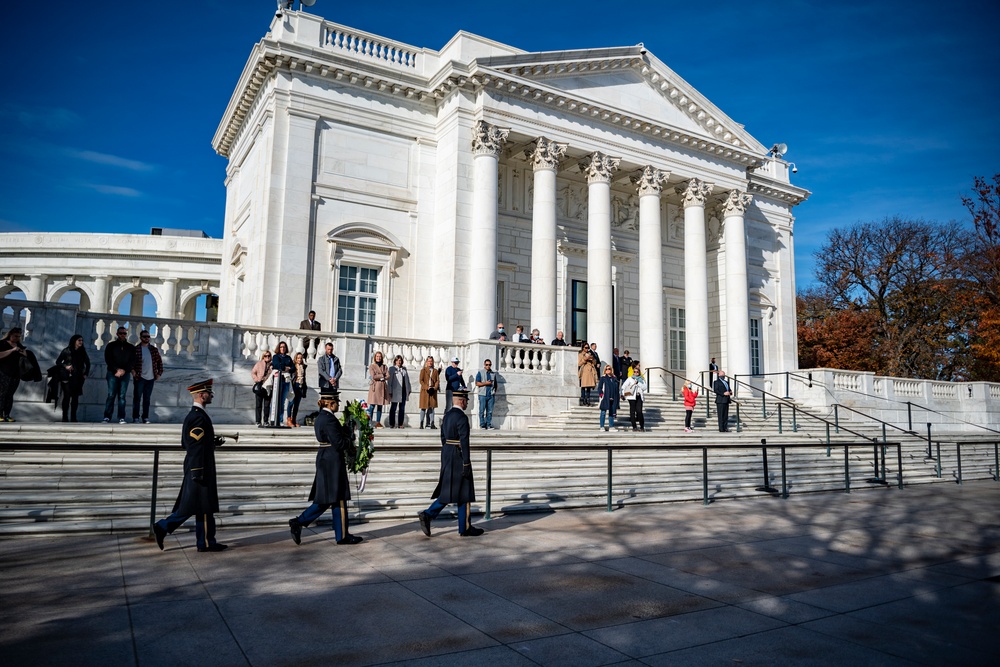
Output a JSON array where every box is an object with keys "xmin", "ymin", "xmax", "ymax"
[{"xmin": 580, "ymin": 153, "xmax": 621, "ymax": 360}]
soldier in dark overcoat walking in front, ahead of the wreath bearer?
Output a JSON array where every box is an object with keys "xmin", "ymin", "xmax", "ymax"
[{"xmin": 417, "ymin": 389, "xmax": 483, "ymax": 537}]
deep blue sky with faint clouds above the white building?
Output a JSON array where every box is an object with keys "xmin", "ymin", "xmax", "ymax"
[{"xmin": 0, "ymin": 0, "xmax": 1000, "ymax": 289}]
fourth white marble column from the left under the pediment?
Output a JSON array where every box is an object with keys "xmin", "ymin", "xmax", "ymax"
[{"xmin": 632, "ymin": 166, "xmax": 669, "ymax": 393}]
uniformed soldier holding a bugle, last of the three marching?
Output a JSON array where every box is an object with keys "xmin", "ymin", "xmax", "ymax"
[{"xmin": 153, "ymin": 380, "xmax": 226, "ymax": 551}]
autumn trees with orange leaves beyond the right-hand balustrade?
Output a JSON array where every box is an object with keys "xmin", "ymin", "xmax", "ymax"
[{"xmin": 798, "ymin": 174, "xmax": 1000, "ymax": 381}]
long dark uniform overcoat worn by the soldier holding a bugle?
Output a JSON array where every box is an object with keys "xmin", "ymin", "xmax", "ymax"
[{"xmin": 174, "ymin": 405, "xmax": 219, "ymax": 515}]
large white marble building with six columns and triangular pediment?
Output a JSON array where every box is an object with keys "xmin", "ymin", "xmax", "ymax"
[{"xmin": 213, "ymin": 11, "xmax": 808, "ymax": 384}]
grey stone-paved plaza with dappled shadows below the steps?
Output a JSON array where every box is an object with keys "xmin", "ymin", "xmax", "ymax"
[{"xmin": 0, "ymin": 481, "xmax": 1000, "ymax": 667}]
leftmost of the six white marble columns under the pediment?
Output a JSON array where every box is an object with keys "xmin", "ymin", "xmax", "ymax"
[{"xmin": 466, "ymin": 120, "xmax": 510, "ymax": 338}]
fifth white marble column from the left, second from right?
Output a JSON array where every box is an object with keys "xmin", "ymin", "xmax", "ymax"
[{"xmin": 677, "ymin": 178, "xmax": 716, "ymax": 382}]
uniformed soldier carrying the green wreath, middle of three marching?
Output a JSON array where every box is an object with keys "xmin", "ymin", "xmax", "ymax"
[{"xmin": 288, "ymin": 389, "xmax": 364, "ymax": 544}]
